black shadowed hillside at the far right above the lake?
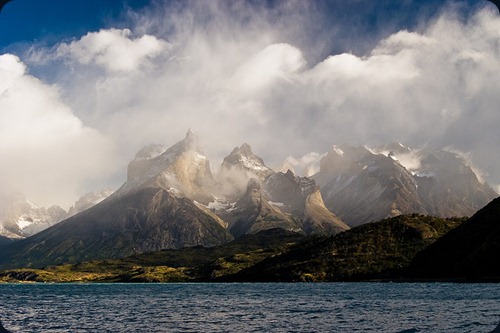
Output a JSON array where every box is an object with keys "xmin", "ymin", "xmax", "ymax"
[{"xmin": 410, "ymin": 198, "xmax": 500, "ymax": 280}]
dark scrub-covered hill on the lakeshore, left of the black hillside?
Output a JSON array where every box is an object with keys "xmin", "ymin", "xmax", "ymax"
[{"xmin": 222, "ymin": 215, "xmax": 463, "ymax": 282}]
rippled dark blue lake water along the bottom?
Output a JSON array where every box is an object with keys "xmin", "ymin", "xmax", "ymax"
[{"xmin": 0, "ymin": 283, "xmax": 500, "ymax": 333}]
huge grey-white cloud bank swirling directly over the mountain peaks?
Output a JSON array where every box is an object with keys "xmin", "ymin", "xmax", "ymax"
[{"xmin": 6, "ymin": 1, "xmax": 500, "ymax": 208}]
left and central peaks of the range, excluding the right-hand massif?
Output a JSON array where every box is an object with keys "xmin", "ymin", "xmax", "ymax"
[{"xmin": 0, "ymin": 131, "xmax": 349, "ymax": 266}]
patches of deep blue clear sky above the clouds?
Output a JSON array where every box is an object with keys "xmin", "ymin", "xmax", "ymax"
[{"xmin": 0, "ymin": 0, "xmax": 484, "ymax": 52}]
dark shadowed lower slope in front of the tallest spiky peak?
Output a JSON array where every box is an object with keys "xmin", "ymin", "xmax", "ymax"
[{"xmin": 0, "ymin": 188, "xmax": 232, "ymax": 267}]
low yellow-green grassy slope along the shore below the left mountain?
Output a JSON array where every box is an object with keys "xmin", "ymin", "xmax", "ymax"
[{"xmin": 0, "ymin": 229, "xmax": 304, "ymax": 282}]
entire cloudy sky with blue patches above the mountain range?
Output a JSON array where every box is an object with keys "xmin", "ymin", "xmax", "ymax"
[{"xmin": 0, "ymin": 0, "xmax": 500, "ymax": 208}]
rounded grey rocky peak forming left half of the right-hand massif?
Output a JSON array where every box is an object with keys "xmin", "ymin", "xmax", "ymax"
[{"xmin": 313, "ymin": 146, "xmax": 426, "ymax": 226}]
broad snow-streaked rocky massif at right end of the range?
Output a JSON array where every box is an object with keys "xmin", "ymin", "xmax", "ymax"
[{"xmin": 312, "ymin": 144, "xmax": 496, "ymax": 226}]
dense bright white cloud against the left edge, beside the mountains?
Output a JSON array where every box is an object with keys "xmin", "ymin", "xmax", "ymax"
[{"xmin": 0, "ymin": 54, "xmax": 113, "ymax": 206}]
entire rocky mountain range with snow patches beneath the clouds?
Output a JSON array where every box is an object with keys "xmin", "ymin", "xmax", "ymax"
[{"xmin": 0, "ymin": 131, "xmax": 496, "ymax": 267}]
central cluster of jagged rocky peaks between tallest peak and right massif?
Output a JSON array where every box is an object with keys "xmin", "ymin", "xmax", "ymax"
[{"xmin": 215, "ymin": 143, "xmax": 349, "ymax": 237}]
